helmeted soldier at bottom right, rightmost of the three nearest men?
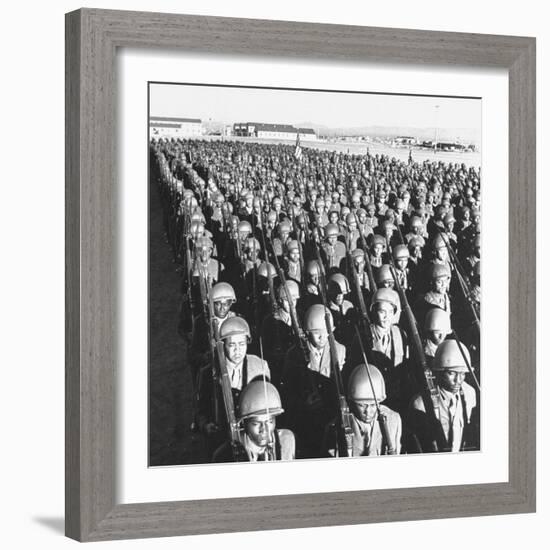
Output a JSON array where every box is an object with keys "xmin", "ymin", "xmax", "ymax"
[{"xmin": 409, "ymin": 340, "xmax": 479, "ymax": 452}]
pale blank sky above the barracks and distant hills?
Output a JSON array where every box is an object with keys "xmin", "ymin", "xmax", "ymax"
[{"xmin": 150, "ymin": 84, "xmax": 481, "ymax": 141}]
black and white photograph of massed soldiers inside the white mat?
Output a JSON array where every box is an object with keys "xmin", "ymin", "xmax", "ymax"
[{"xmin": 147, "ymin": 82, "xmax": 483, "ymax": 467}]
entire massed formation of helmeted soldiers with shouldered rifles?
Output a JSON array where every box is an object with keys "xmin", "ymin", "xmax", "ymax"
[{"xmin": 150, "ymin": 139, "xmax": 480, "ymax": 462}]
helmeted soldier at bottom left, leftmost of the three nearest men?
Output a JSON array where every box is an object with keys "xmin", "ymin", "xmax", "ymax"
[{"xmin": 213, "ymin": 380, "xmax": 296, "ymax": 462}]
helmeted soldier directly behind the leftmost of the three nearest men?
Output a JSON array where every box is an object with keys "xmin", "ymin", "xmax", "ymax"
[{"xmin": 198, "ymin": 317, "xmax": 270, "ymax": 442}]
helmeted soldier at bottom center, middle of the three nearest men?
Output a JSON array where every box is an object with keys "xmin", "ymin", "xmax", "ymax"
[{"xmin": 327, "ymin": 364, "xmax": 402, "ymax": 456}]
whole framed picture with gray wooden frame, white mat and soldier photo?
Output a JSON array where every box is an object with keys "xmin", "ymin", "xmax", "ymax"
[{"xmin": 66, "ymin": 9, "xmax": 535, "ymax": 541}]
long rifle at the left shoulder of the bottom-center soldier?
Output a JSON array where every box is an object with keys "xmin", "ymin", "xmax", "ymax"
[{"xmin": 308, "ymin": 218, "xmax": 353, "ymax": 457}]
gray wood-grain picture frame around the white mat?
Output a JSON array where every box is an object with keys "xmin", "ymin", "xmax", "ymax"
[{"xmin": 66, "ymin": 9, "xmax": 535, "ymax": 541}]
